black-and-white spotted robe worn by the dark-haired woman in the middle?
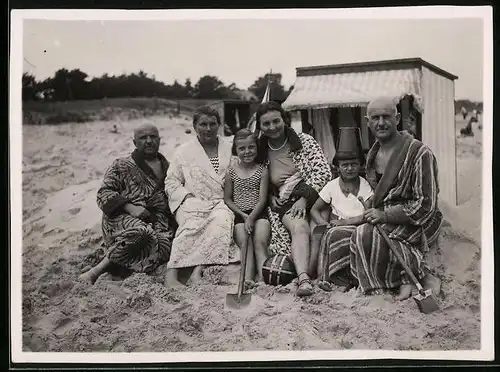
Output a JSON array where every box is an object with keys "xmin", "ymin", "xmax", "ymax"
[{"xmin": 259, "ymin": 127, "xmax": 332, "ymax": 256}]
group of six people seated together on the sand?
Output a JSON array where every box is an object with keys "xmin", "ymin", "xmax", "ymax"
[{"xmin": 81, "ymin": 97, "xmax": 442, "ymax": 299}]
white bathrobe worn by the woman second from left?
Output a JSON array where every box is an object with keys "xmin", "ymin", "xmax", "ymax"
[{"xmin": 165, "ymin": 137, "xmax": 239, "ymax": 268}]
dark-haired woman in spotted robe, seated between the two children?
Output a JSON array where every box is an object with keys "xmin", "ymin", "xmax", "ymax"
[{"xmin": 256, "ymin": 102, "xmax": 332, "ymax": 296}]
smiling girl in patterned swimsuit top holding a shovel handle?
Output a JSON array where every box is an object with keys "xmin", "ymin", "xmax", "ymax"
[{"xmin": 224, "ymin": 129, "xmax": 271, "ymax": 287}]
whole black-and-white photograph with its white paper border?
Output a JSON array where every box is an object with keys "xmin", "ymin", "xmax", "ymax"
[{"xmin": 11, "ymin": 8, "xmax": 493, "ymax": 360}]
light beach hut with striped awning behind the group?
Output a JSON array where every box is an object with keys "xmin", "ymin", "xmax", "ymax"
[{"xmin": 283, "ymin": 58, "xmax": 458, "ymax": 206}]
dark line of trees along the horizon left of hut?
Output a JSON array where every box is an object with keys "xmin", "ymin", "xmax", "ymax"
[{"xmin": 22, "ymin": 68, "xmax": 293, "ymax": 102}]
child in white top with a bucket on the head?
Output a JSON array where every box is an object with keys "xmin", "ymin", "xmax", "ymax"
[{"xmin": 311, "ymin": 128, "xmax": 373, "ymax": 289}]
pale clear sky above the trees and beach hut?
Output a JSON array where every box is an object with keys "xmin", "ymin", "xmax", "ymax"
[{"xmin": 23, "ymin": 18, "xmax": 483, "ymax": 100}]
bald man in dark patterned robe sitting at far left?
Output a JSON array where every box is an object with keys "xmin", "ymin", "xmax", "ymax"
[{"xmin": 80, "ymin": 124, "xmax": 176, "ymax": 284}]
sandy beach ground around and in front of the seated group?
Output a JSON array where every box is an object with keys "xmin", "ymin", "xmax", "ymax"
[{"xmin": 22, "ymin": 116, "xmax": 482, "ymax": 352}]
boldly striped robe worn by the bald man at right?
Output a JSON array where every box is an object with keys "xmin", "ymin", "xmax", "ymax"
[{"xmin": 323, "ymin": 133, "xmax": 443, "ymax": 293}]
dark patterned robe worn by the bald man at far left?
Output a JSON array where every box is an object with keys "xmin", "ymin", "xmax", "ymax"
[{"xmin": 97, "ymin": 150, "xmax": 175, "ymax": 272}]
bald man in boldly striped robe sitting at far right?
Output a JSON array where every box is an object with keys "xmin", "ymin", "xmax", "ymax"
[{"xmin": 320, "ymin": 97, "xmax": 443, "ymax": 300}]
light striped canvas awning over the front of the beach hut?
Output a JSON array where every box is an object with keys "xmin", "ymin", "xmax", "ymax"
[{"xmin": 283, "ymin": 68, "xmax": 423, "ymax": 111}]
